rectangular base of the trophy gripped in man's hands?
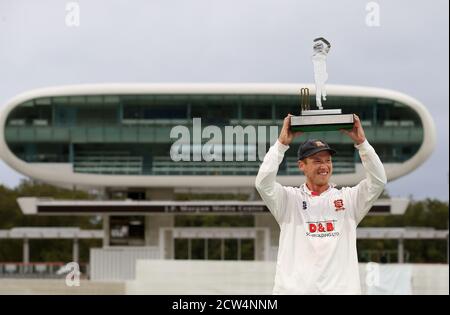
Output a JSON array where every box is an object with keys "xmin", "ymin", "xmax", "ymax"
[{"xmin": 291, "ymin": 110, "xmax": 354, "ymax": 132}]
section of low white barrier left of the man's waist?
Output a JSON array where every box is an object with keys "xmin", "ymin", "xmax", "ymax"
[{"xmin": 126, "ymin": 260, "xmax": 275, "ymax": 295}]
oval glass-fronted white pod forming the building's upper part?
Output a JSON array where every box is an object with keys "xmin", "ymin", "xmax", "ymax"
[{"xmin": 0, "ymin": 84, "xmax": 436, "ymax": 190}]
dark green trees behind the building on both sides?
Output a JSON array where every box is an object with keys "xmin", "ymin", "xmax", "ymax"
[{"xmin": 0, "ymin": 180, "xmax": 449, "ymax": 263}]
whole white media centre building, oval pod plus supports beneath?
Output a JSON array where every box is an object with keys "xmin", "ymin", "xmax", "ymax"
[{"xmin": 0, "ymin": 84, "xmax": 436, "ymax": 272}]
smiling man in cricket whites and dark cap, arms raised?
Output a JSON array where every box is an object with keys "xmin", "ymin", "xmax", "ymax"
[{"xmin": 255, "ymin": 38, "xmax": 387, "ymax": 294}]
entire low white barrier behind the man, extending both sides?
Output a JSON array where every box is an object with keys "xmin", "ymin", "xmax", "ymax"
[{"xmin": 126, "ymin": 260, "xmax": 449, "ymax": 294}]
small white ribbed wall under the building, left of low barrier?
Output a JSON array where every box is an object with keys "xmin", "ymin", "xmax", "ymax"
[{"xmin": 90, "ymin": 246, "xmax": 160, "ymax": 281}]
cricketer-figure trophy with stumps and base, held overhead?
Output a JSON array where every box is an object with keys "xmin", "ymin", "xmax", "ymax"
[{"xmin": 291, "ymin": 37, "xmax": 353, "ymax": 132}]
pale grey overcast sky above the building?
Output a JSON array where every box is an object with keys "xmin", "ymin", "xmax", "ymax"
[{"xmin": 0, "ymin": 0, "xmax": 449, "ymax": 200}]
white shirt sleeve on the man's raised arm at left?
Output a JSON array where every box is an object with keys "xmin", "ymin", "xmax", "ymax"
[{"xmin": 255, "ymin": 140, "xmax": 289, "ymax": 224}]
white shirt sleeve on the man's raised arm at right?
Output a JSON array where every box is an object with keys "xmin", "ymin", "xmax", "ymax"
[{"xmin": 350, "ymin": 140, "xmax": 387, "ymax": 225}]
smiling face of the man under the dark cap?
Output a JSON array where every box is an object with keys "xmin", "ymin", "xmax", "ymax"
[{"xmin": 298, "ymin": 151, "xmax": 333, "ymax": 186}]
